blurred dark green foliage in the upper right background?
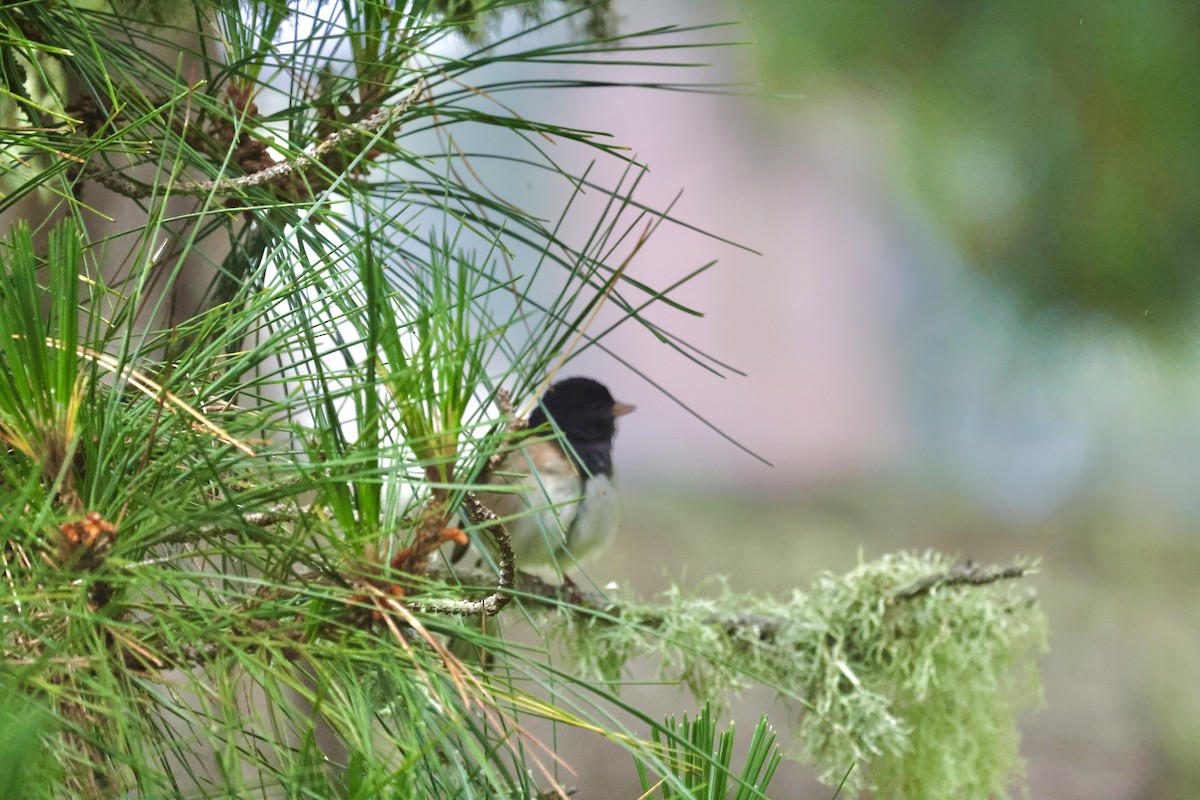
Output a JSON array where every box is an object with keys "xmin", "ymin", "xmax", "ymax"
[{"xmin": 733, "ymin": 0, "xmax": 1200, "ymax": 336}]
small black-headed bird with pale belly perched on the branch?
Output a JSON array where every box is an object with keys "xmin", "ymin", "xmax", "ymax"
[{"xmin": 478, "ymin": 378, "xmax": 634, "ymax": 572}]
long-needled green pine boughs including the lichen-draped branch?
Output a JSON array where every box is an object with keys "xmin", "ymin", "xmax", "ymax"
[{"xmin": 0, "ymin": 0, "xmax": 1042, "ymax": 799}]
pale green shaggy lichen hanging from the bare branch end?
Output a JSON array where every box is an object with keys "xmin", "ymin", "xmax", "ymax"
[{"xmin": 549, "ymin": 553, "xmax": 1048, "ymax": 800}]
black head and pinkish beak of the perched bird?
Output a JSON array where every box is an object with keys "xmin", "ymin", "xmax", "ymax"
[{"xmin": 529, "ymin": 378, "xmax": 634, "ymax": 474}]
